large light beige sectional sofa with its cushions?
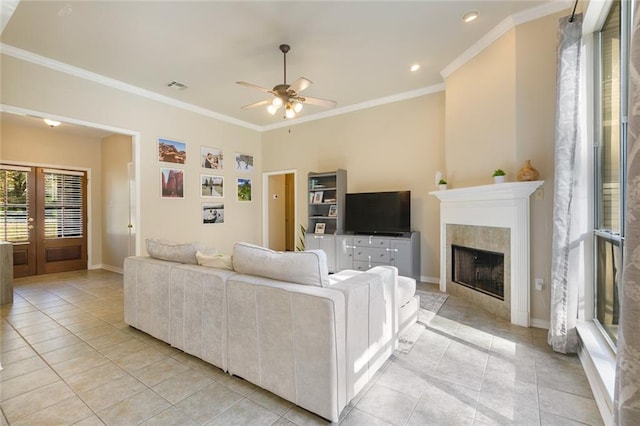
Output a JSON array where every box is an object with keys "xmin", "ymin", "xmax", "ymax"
[{"xmin": 124, "ymin": 240, "xmax": 419, "ymax": 421}]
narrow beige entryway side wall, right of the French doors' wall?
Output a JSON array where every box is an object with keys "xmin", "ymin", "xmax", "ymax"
[{"xmin": 101, "ymin": 135, "xmax": 133, "ymax": 271}]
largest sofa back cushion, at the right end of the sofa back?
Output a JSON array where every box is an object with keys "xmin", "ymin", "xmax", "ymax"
[{"xmin": 233, "ymin": 243, "xmax": 329, "ymax": 287}]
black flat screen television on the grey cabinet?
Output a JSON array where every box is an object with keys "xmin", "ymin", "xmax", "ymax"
[{"xmin": 344, "ymin": 191, "xmax": 411, "ymax": 235}]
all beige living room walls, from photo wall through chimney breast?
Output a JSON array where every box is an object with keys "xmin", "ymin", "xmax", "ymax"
[{"xmin": 1, "ymin": 10, "xmax": 562, "ymax": 321}]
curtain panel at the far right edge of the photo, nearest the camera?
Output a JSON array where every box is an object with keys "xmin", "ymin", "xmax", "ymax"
[{"xmin": 614, "ymin": 1, "xmax": 640, "ymax": 425}]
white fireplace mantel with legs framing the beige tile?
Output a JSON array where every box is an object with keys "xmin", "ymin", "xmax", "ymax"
[{"xmin": 430, "ymin": 181, "xmax": 544, "ymax": 327}]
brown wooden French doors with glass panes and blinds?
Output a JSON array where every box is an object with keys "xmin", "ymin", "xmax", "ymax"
[{"xmin": 0, "ymin": 164, "xmax": 87, "ymax": 278}]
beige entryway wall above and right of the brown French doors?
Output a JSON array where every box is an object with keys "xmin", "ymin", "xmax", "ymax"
[{"xmin": 0, "ymin": 123, "xmax": 103, "ymax": 267}]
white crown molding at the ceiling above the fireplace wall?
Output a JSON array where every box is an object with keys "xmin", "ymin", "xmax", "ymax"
[{"xmin": 440, "ymin": 0, "xmax": 573, "ymax": 80}]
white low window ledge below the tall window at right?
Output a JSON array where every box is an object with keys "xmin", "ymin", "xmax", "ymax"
[{"xmin": 577, "ymin": 322, "xmax": 616, "ymax": 426}]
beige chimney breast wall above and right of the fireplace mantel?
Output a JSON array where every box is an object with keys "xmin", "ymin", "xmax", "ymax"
[{"xmin": 445, "ymin": 13, "xmax": 566, "ymax": 324}]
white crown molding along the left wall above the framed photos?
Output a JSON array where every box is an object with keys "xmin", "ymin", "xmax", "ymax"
[{"xmin": 0, "ymin": 43, "xmax": 261, "ymax": 131}]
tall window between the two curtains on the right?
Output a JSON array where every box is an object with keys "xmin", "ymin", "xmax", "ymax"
[{"xmin": 594, "ymin": 1, "xmax": 629, "ymax": 347}]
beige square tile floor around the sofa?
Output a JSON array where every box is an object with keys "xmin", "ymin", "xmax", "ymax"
[{"xmin": 0, "ymin": 270, "xmax": 602, "ymax": 425}]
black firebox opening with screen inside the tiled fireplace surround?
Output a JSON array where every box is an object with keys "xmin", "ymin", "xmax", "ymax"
[{"xmin": 451, "ymin": 244, "xmax": 504, "ymax": 300}]
